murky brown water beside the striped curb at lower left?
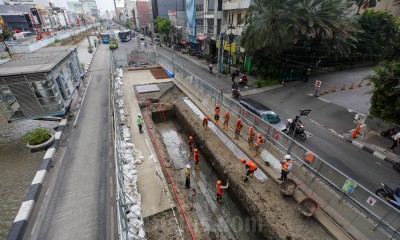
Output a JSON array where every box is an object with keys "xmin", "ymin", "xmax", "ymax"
[{"xmin": 0, "ymin": 116, "xmax": 58, "ymax": 239}]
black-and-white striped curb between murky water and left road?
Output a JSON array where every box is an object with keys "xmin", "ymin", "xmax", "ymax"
[{"xmin": 6, "ymin": 119, "xmax": 67, "ymax": 240}]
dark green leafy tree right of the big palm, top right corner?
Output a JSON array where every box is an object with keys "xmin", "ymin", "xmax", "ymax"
[{"xmin": 355, "ymin": 10, "xmax": 400, "ymax": 60}]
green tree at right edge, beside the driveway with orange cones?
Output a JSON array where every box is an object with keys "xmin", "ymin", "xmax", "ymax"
[{"xmin": 368, "ymin": 60, "xmax": 400, "ymax": 124}]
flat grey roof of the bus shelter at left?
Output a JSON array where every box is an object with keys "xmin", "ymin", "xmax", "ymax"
[{"xmin": 0, "ymin": 46, "xmax": 76, "ymax": 77}]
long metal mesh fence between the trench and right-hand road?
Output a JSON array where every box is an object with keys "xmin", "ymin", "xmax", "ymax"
[{"xmin": 159, "ymin": 55, "xmax": 400, "ymax": 239}]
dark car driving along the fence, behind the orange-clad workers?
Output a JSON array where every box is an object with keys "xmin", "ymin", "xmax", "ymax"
[{"xmin": 240, "ymin": 98, "xmax": 286, "ymax": 131}]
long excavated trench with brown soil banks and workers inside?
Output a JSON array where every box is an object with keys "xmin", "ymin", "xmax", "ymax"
[{"xmin": 119, "ymin": 65, "xmax": 334, "ymax": 240}]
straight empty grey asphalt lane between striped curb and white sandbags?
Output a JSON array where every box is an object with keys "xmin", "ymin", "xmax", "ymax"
[{"xmin": 24, "ymin": 45, "xmax": 117, "ymax": 240}]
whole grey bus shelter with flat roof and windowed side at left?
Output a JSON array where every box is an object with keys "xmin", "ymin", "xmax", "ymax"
[{"xmin": 0, "ymin": 46, "xmax": 83, "ymax": 121}]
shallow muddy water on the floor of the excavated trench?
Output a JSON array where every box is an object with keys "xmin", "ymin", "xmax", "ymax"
[{"xmin": 157, "ymin": 121, "xmax": 257, "ymax": 240}]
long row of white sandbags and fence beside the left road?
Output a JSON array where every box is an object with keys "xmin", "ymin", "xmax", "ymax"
[{"xmin": 111, "ymin": 54, "xmax": 145, "ymax": 240}]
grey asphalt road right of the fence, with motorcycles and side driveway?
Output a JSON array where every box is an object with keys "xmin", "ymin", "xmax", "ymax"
[{"xmin": 157, "ymin": 47, "xmax": 399, "ymax": 192}]
